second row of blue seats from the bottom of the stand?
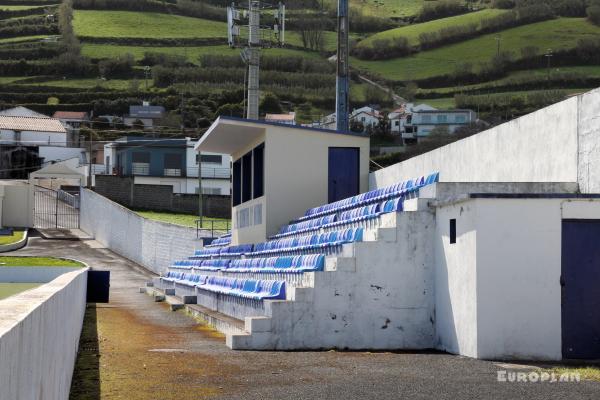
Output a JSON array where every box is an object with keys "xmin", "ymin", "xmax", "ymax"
[{"xmin": 170, "ymin": 254, "xmax": 325, "ymax": 273}]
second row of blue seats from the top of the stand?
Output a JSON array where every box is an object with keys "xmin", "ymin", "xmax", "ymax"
[{"xmin": 271, "ymin": 197, "xmax": 404, "ymax": 239}]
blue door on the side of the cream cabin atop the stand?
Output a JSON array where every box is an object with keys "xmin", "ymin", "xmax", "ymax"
[{"xmin": 328, "ymin": 147, "xmax": 360, "ymax": 203}]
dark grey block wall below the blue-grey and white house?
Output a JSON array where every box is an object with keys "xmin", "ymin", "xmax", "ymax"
[{"xmin": 95, "ymin": 175, "xmax": 231, "ymax": 219}]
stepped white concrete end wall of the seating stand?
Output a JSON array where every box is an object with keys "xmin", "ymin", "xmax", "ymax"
[{"xmin": 227, "ymin": 211, "xmax": 435, "ymax": 349}]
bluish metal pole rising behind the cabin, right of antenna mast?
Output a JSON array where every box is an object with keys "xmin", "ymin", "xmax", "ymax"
[{"xmin": 335, "ymin": 0, "xmax": 350, "ymax": 132}]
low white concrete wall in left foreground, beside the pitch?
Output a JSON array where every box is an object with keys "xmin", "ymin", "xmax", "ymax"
[{"xmin": 0, "ymin": 268, "xmax": 87, "ymax": 400}]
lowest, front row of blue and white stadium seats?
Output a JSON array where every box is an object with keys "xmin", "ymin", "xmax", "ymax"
[{"xmin": 161, "ymin": 271, "xmax": 285, "ymax": 300}]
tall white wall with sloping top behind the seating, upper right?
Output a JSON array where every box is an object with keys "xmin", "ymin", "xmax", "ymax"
[{"xmin": 370, "ymin": 96, "xmax": 580, "ymax": 188}]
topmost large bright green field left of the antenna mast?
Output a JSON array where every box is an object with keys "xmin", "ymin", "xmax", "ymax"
[{"xmin": 73, "ymin": 10, "xmax": 227, "ymax": 39}]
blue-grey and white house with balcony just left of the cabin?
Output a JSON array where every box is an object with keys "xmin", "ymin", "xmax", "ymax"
[{"xmin": 104, "ymin": 136, "xmax": 231, "ymax": 195}]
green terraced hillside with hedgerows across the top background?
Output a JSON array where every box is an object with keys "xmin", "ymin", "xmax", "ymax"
[{"xmin": 0, "ymin": 0, "xmax": 600, "ymax": 129}]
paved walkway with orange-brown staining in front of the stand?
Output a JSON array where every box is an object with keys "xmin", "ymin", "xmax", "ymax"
[{"xmin": 11, "ymin": 238, "xmax": 600, "ymax": 400}]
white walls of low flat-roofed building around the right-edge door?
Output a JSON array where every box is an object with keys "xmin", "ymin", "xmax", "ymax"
[{"xmin": 435, "ymin": 198, "xmax": 600, "ymax": 360}]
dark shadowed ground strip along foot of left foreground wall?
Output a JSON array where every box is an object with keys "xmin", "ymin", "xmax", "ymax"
[{"xmin": 69, "ymin": 304, "xmax": 100, "ymax": 400}]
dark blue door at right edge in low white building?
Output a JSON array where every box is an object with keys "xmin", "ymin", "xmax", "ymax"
[{"xmin": 560, "ymin": 220, "xmax": 600, "ymax": 359}]
